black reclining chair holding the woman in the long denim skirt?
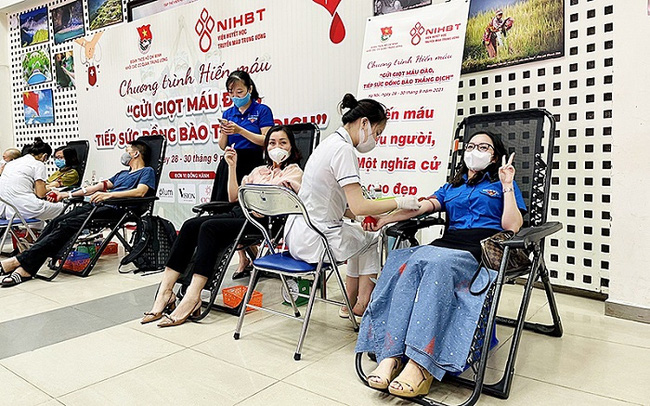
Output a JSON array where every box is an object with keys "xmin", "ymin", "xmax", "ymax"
[{"xmin": 356, "ymin": 109, "xmax": 562, "ymax": 405}]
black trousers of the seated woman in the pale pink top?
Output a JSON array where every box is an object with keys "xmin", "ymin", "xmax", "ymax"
[{"xmin": 167, "ymin": 206, "xmax": 266, "ymax": 278}]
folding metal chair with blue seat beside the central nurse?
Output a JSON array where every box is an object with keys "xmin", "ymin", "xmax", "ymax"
[{"xmin": 234, "ymin": 185, "xmax": 359, "ymax": 361}]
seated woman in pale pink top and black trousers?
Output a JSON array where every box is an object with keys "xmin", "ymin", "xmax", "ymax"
[{"xmin": 141, "ymin": 126, "xmax": 302, "ymax": 327}]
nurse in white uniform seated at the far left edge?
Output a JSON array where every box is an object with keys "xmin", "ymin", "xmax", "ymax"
[{"xmin": 0, "ymin": 137, "xmax": 63, "ymax": 220}]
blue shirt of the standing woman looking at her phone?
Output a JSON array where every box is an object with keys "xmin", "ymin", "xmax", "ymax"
[{"xmin": 222, "ymin": 101, "xmax": 274, "ymax": 149}]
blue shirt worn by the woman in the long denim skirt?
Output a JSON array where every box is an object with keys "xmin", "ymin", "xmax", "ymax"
[{"xmin": 433, "ymin": 173, "xmax": 527, "ymax": 230}]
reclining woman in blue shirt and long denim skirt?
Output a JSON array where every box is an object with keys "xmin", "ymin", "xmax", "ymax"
[{"xmin": 355, "ymin": 132, "xmax": 526, "ymax": 397}]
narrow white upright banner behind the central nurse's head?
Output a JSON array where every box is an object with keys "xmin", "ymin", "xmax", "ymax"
[{"xmin": 357, "ymin": 0, "xmax": 468, "ymax": 196}]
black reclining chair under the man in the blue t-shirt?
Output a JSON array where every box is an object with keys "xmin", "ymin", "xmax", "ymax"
[{"xmin": 37, "ymin": 135, "xmax": 171, "ymax": 281}]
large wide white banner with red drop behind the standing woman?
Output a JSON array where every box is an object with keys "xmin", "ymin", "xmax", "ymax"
[{"xmin": 74, "ymin": 0, "xmax": 372, "ymax": 226}]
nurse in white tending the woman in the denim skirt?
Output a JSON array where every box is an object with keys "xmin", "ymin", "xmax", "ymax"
[{"xmin": 285, "ymin": 93, "xmax": 420, "ymax": 317}]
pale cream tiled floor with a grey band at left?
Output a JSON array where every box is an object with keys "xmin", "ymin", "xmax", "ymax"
[{"xmin": 0, "ymin": 258, "xmax": 650, "ymax": 406}]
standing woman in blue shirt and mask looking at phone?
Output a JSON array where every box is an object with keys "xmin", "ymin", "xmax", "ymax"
[{"xmin": 212, "ymin": 70, "xmax": 274, "ymax": 201}]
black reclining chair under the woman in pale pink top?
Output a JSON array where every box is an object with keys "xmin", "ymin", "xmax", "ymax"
[{"xmin": 178, "ymin": 123, "xmax": 320, "ymax": 321}]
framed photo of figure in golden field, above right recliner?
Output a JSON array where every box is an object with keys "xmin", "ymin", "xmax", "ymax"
[{"xmin": 461, "ymin": 0, "xmax": 564, "ymax": 73}]
